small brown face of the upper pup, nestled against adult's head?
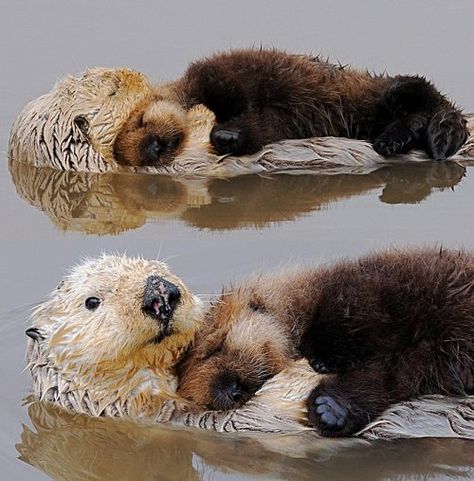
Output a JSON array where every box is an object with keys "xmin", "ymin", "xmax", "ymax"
[{"xmin": 114, "ymin": 95, "xmax": 187, "ymax": 167}]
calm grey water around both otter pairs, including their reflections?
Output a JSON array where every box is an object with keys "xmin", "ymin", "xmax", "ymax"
[{"xmin": 0, "ymin": 0, "xmax": 474, "ymax": 481}]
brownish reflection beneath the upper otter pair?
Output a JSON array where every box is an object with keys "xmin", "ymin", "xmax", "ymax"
[{"xmin": 9, "ymin": 161, "xmax": 465, "ymax": 234}]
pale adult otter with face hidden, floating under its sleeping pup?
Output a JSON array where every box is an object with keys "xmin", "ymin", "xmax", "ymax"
[{"xmin": 9, "ymin": 68, "xmax": 474, "ymax": 177}]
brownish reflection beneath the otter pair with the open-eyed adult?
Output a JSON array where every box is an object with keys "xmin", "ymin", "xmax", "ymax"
[{"xmin": 17, "ymin": 402, "xmax": 474, "ymax": 481}]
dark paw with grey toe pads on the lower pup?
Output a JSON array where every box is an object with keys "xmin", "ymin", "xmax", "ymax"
[{"xmin": 307, "ymin": 386, "xmax": 364, "ymax": 437}]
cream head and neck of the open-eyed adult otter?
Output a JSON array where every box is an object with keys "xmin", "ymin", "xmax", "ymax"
[{"xmin": 26, "ymin": 255, "xmax": 202, "ymax": 412}]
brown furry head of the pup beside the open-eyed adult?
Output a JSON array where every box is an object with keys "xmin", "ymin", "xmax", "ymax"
[{"xmin": 178, "ymin": 287, "xmax": 291, "ymax": 410}]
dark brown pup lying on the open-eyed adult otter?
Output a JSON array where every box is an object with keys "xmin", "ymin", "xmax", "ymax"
[{"xmin": 178, "ymin": 249, "xmax": 474, "ymax": 436}]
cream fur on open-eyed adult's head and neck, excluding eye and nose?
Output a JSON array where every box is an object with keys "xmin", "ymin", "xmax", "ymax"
[{"xmin": 28, "ymin": 255, "xmax": 202, "ymax": 417}]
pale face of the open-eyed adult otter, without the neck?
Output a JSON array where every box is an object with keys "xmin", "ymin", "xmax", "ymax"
[{"xmin": 27, "ymin": 255, "xmax": 202, "ymax": 368}]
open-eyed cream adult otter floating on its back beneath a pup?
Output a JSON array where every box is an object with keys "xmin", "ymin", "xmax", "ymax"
[{"xmin": 27, "ymin": 256, "xmax": 474, "ymax": 438}]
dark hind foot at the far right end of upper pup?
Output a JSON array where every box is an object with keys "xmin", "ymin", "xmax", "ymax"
[{"xmin": 426, "ymin": 110, "xmax": 469, "ymax": 160}]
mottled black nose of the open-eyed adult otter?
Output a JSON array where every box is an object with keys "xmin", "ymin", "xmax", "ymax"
[{"xmin": 142, "ymin": 276, "xmax": 181, "ymax": 330}]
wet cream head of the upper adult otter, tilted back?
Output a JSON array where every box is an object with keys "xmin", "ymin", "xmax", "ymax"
[{"xmin": 9, "ymin": 68, "xmax": 151, "ymax": 172}]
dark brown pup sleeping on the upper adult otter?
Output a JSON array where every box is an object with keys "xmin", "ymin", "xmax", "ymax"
[{"xmin": 115, "ymin": 49, "xmax": 468, "ymax": 165}]
